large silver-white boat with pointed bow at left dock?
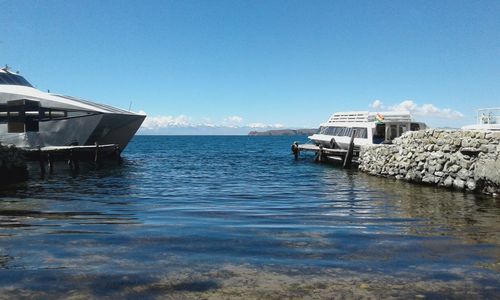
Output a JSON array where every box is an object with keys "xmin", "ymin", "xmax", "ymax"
[{"xmin": 0, "ymin": 66, "xmax": 146, "ymax": 150}]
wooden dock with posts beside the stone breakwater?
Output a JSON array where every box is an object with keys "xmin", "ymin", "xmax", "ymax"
[{"xmin": 291, "ymin": 134, "xmax": 360, "ymax": 168}]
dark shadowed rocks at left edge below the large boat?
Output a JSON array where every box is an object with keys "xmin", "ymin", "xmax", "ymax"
[{"xmin": 0, "ymin": 145, "xmax": 28, "ymax": 187}]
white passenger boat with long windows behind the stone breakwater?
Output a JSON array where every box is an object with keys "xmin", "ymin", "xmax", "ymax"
[{"xmin": 309, "ymin": 111, "xmax": 427, "ymax": 149}]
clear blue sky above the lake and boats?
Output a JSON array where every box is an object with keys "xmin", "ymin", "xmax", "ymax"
[{"xmin": 0, "ymin": 0, "xmax": 500, "ymax": 132}]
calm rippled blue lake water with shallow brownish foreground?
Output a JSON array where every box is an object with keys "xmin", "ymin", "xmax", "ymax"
[{"xmin": 0, "ymin": 136, "xmax": 500, "ymax": 299}]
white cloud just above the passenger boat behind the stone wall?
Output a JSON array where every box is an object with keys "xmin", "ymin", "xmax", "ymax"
[{"xmin": 370, "ymin": 100, "xmax": 464, "ymax": 119}]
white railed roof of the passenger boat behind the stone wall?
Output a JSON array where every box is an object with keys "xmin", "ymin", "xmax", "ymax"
[{"xmin": 327, "ymin": 111, "xmax": 412, "ymax": 123}]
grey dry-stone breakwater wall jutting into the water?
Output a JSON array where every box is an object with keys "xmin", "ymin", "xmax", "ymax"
[{"xmin": 359, "ymin": 129, "xmax": 500, "ymax": 195}]
